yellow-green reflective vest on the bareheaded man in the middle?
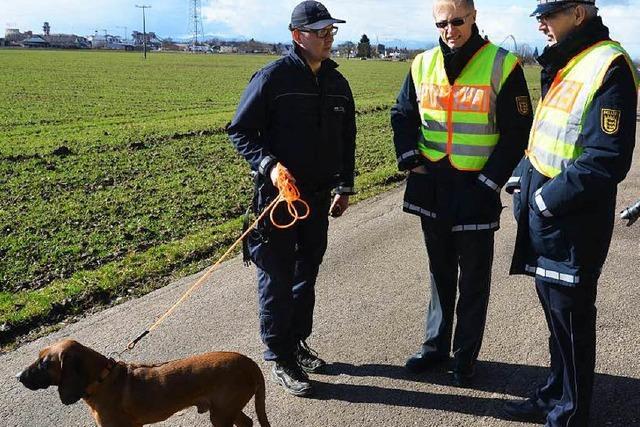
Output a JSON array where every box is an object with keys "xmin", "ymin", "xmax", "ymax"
[{"xmin": 411, "ymin": 43, "xmax": 518, "ymax": 171}]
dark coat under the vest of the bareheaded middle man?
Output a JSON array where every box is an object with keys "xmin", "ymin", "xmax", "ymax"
[{"xmin": 391, "ymin": 28, "xmax": 533, "ymax": 231}]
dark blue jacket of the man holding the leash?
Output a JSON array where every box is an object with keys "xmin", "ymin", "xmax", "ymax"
[{"xmin": 227, "ymin": 44, "xmax": 356, "ymax": 194}]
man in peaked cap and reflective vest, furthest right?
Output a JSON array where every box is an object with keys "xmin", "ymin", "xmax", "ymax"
[{"xmin": 505, "ymin": 0, "xmax": 638, "ymax": 427}]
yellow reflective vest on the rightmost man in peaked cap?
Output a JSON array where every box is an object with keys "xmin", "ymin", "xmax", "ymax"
[{"xmin": 527, "ymin": 41, "xmax": 638, "ymax": 178}]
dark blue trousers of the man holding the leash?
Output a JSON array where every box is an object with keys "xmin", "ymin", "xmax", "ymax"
[{"xmin": 248, "ymin": 191, "xmax": 331, "ymax": 361}]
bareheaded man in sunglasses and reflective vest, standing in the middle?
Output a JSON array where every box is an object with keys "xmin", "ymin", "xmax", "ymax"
[{"xmin": 391, "ymin": 0, "xmax": 533, "ymax": 386}]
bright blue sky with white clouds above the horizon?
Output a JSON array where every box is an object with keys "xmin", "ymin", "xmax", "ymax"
[{"xmin": 0, "ymin": 0, "xmax": 640, "ymax": 58}]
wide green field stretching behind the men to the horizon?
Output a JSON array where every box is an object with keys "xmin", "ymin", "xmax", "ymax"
[{"xmin": 0, "ymin": 50, "xmax": 535, "ymax": 344}]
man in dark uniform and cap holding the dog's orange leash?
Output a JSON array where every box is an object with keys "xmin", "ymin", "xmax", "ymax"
[{"xmin": 228, "ymin": 1, "xmax": 356, "ymax": 396}]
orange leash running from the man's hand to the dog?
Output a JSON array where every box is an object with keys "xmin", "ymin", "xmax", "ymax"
[{"xmin": 124, "ymin": 164, "xmax": 311, "ymax": 355}]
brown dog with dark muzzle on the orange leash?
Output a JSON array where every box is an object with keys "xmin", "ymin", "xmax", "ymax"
[{"xmin": 18, "ymin": 340, "xmax": 269, "ymax": 427}]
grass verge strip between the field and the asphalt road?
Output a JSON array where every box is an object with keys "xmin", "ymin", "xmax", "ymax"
[{"xmin": 0, "ymin": 108, "xmax": 404, "ymax": 351}]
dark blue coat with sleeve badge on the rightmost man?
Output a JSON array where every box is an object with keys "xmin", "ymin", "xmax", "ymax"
[{"xmin": 507, "ymin": 18, "xmax": 637, "ymax": 286}]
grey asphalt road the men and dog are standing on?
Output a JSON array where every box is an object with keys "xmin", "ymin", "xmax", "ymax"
[{"xmin": 0, "ymin": 129, "xmax": 640, "ymax": 427}]
